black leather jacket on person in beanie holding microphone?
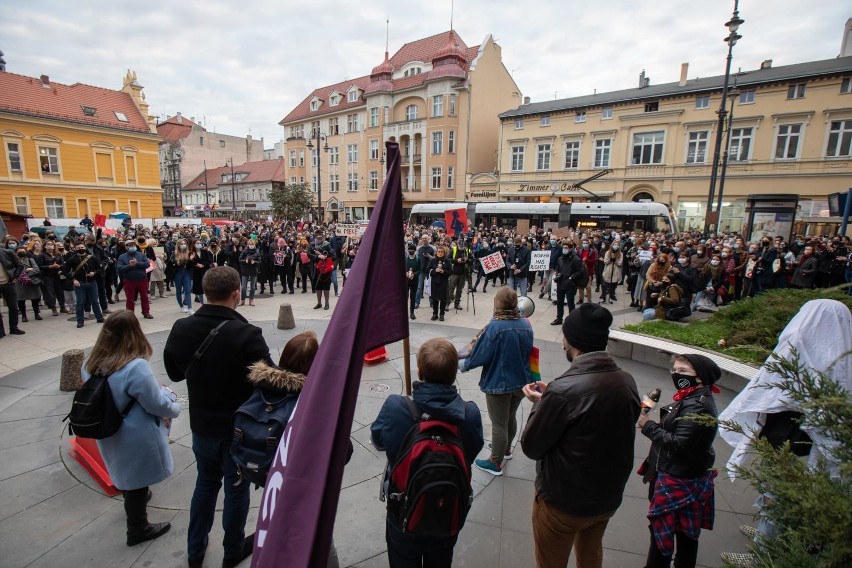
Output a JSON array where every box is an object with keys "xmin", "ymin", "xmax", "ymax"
[{"xmin": 642, "ymin": 386, "xmax": 718, "ymax": 479}]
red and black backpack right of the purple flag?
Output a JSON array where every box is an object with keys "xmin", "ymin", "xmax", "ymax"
[{"xmin": 381, "ymin": 396, "xmax": 473, "ymax": 537}]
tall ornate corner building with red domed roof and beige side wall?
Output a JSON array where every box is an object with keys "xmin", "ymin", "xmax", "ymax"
[{"xmin": 280, "ymin": 30, "xmax": 521, "ymax": 221}]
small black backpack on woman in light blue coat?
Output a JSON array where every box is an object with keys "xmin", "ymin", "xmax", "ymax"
[{"xmin": 62, "ymin": 375, "xmax": 136, "ymax": 440}]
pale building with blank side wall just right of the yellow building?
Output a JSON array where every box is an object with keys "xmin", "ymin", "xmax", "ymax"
[{"xmin": 157, "ymin": 113, "xmax": 264, "ymax": 217}]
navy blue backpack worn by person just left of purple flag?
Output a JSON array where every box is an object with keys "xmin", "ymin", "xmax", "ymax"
[{"xmin": 231, "ymin": 389, "xmax": 299, "ymax": 487}]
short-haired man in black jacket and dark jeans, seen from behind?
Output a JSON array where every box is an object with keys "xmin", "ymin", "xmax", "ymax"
[{"xmin": 163, "ymin": 266, "xmax": 273, "ymax": 566}]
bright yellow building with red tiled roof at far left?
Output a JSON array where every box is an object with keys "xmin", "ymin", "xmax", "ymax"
[{"xmin": 0, "ymin": 71, "xmax": 162, "ymax": 224}]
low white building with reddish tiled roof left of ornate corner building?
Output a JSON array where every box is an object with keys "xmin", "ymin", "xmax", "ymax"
[{"xmin": 183, "ymin": 158, "xmax": 284, "ymax": 219}]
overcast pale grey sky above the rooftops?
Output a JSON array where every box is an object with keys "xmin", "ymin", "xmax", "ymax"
[{"xmin": 0, "ymin": 0, "xmax": 852, "ymax": 148}]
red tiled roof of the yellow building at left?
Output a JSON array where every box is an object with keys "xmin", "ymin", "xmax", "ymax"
[{"xmin": 0, "ymin": 72, "xmax": 151, "ymax": 133}]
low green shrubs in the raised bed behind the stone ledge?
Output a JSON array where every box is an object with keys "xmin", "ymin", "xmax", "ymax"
[{"xmin": 624, "ymin": 287, "xmax": 852, "ymax": 365}]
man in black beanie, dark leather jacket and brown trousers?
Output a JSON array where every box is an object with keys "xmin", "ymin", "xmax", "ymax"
[{"xmin": 521, "ymin": 304, "xmax": 640, "ymax": 568}]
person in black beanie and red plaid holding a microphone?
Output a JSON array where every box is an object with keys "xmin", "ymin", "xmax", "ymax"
[{"xmin": 636, "ymin": 354, "xmax": 722, "ymax": 568}]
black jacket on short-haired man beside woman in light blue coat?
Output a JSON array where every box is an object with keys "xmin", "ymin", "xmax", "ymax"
[{"xmin": 163, "ymin": 304, "xmax": 272, "ymax": 440}]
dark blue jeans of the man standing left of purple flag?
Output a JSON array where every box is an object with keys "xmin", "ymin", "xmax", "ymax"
[{"xmin": 187, "ymin": 434, "xmax": 251, "ymax": 558}]
